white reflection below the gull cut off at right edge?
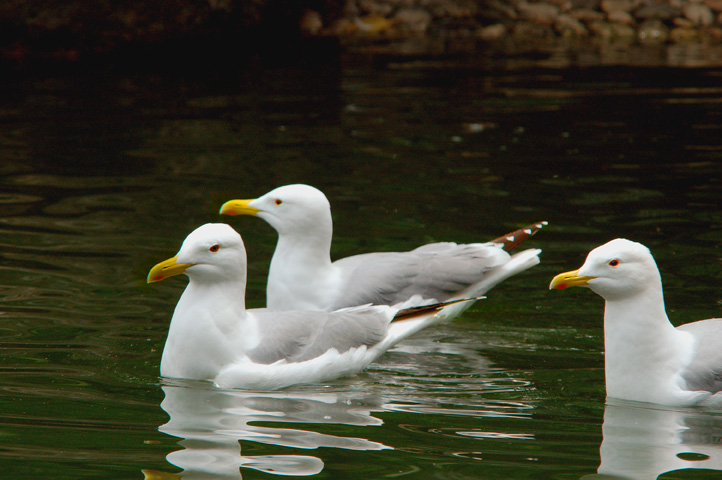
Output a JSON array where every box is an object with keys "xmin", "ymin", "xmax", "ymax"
[{"xmin": 582, "ymin": 399, "xmax": 722, "ymax": 480}]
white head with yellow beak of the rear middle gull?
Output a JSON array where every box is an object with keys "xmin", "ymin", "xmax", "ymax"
[{"xmin": 220, "ymin": 184, "xmax": 331, "ymax": 234}]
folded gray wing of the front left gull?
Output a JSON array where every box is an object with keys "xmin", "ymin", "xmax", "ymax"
[{"xmin": 248, "ymin": 308, "xmax": 392, "ymax": 364}]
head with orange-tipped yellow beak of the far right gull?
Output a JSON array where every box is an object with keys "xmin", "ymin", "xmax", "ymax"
[{"xmin": 549, "ymin": 238, "xmax": 661, "ymax": 300}]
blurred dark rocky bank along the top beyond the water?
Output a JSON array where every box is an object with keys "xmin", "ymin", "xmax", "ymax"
[{"xmin": 0, "ymin": 0, "xmax": 722, "ymax": 66}]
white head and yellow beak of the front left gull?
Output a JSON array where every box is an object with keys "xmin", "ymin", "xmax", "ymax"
[{"xmin": 148, "ymin": 223, "xmax": 246, "ymax": 283}]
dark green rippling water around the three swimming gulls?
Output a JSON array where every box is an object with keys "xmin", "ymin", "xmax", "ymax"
[{"xmin": 0, "ymin": 54, "xmax": 722, "ymax": 480}]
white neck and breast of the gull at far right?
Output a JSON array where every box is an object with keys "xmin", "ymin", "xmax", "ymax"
[{"xmin": 604, "ymin": 283, "xmax": 693, "ymax": 404}]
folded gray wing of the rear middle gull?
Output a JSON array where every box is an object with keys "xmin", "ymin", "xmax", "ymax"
[{"xmin": 333, "ymin": 242, "xmax": 509, "ymax": 309}]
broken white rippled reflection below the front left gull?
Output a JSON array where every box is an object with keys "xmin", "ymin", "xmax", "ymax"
[{"xmin": 144, "ymin": 381, "xmax": 390, "ymax": 480}]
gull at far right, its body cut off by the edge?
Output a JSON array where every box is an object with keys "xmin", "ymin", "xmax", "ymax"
[{"xmin": 549, "ymin": 238, "xmax": 722, "ymax": 406}]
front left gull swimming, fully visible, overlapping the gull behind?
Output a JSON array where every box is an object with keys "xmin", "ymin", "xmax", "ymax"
[{"xmin": 148, "ymin": 223, "xmax": 476, "ymax": 390}]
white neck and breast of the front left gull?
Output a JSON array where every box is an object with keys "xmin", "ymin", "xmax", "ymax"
[{"xmin": 161, "ymin": 275, "xmax": 248, "ymax": 380}]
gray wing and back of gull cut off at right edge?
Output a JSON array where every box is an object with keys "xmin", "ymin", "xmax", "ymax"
[{"xmin": 677, "ymin": 318, "xmax": 722, "ymax": 393}]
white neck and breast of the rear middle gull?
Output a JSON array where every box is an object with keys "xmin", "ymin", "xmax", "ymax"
[{"xmin": 266, "ymin": 219, "xmax": 340, "ymax": 310}]
